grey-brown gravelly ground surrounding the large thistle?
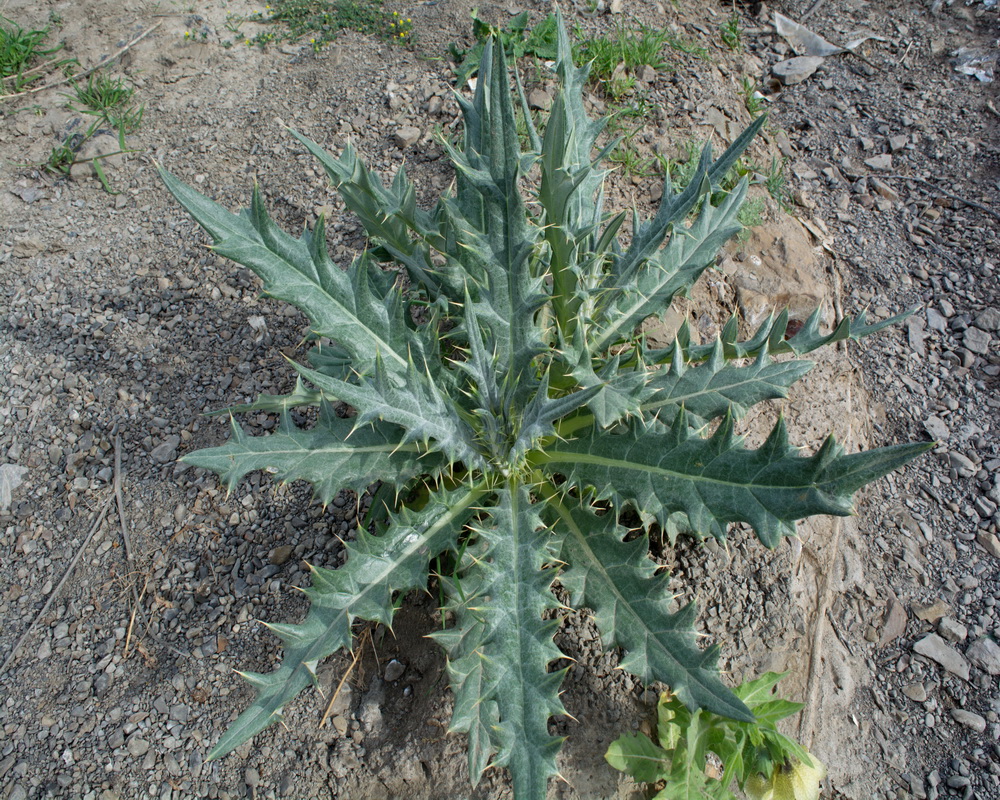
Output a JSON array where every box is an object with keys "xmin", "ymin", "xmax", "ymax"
[{"xmin": 0, "ymin": 0, "xmax": 1000, "ymax": 800}]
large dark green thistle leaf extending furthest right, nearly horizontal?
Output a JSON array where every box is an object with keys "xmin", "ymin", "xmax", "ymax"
[{"xmin": 536, "ymin": 413, "xmax": 933, "ymax": 547}]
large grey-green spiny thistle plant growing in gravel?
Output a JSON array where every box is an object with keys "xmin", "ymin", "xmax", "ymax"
[{"xmin": 163, "ymin": 14, "xmax": 925, "ymax": 800}]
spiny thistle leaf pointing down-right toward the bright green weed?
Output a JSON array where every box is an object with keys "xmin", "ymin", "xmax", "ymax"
[{"xmin": 542, "ymin": 490, "xmax": 753, "ymax": 721}]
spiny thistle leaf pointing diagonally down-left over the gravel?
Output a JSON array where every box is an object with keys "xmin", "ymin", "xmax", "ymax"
[{"xmin": 208, "ymin": 486, "xmax": 485, "ymax": 760}]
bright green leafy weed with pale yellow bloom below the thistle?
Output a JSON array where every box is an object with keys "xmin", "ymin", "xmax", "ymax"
[{"xmin": 605, "ymin": 672, "xmax": 826, "ymax": 800}]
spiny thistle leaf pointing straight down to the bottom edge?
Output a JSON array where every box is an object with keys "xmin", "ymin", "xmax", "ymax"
[{"xmin": 434, "ymin": 481, "xmax": 565, "ymax": 798}]
